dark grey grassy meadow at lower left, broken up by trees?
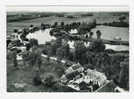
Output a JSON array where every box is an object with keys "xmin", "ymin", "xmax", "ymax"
[{"xmin": 7, "ymin": 55, "xmax": 66, "ymax": 92}]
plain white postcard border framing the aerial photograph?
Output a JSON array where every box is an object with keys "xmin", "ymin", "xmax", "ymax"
[{"xmin": 0, "ymin": 0, "xmax": 134, "ymax": 99}]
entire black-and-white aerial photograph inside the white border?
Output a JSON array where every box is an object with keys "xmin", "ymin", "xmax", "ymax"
[{"xmin": 6, "ymin": 5, "xmax": 130, "ymax": 93}]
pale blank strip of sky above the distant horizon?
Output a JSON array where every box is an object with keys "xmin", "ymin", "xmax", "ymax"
[{"xmin": 7, "ymin": 5, "xmax": 129, "ymax": 13}]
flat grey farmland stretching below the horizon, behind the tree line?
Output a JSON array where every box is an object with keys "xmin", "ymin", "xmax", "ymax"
[{"xmin": 7, "ymin": 12, "xmax": 129, "ymax": 33}]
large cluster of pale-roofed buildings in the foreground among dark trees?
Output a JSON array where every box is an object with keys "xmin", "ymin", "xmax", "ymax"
[{"xmin": 61, "ymin": 64, "xmax": 108, "ymax": 92}]
